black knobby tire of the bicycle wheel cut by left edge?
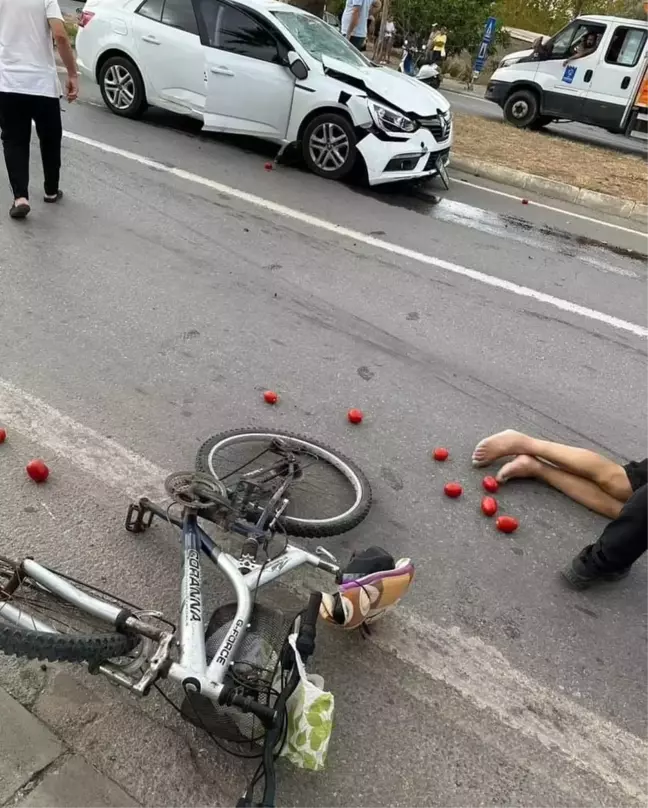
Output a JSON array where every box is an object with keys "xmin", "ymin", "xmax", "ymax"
[{"xmin": 0, "ymin": 556, "xmax": 139, "ymax": 665}]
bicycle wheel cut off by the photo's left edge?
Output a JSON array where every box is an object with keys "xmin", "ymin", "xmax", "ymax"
[{"xmin": 0, "ymin": 556, "xmax": 139, "ymax": 665}]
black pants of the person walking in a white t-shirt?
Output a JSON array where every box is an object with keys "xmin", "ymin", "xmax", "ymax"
[{"xmin": 0, "ymin": 93, "xmax": 63, "ymax": 199}]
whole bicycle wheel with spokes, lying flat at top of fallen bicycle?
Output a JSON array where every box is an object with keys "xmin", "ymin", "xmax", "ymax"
[{"xmin": 196, "ymin": 429, "xmax": 371, "ymax": 538}]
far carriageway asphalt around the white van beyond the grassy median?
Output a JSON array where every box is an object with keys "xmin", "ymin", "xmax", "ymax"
[{"xmin": 441, "ymin": 81, "xmax": 648, "ymax": 157}]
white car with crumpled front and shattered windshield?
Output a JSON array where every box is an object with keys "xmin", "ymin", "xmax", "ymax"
[{"xmin": 77, "ymin": 0, "xmax": 452, "ymax": 185}]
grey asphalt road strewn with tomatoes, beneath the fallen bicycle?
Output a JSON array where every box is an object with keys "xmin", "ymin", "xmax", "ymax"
[{"xmin": 0, "ymin": 77, "xmax": 648, "ymax": 808}]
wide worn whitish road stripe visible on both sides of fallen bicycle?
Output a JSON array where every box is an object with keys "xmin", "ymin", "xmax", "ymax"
[{"xmin": 0, "ymin": 380, "xmax": 648, "ymax": 805}]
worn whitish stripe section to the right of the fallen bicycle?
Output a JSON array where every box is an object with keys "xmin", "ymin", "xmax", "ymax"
[{"xmin": 372, "ymin": 609, "xmax": 648, "ymax": 805}]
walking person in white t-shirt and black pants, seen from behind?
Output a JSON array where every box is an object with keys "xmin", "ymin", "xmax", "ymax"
[{"xmin": 0, "ymin": 0, "xmax": 79, "ymax": 219}]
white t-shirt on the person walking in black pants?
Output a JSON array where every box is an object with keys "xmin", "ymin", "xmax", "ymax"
[{"xmin": 0, "ymin": 0, "xmax": 63, "ymax": 98}]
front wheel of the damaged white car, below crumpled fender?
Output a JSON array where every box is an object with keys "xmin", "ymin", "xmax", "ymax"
[{"xmin": 302, "ymin": 112, "xmax": 358, "ymax": 180}]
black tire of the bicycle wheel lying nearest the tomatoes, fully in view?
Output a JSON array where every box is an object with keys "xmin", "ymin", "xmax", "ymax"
[{"xmin": 196, "ymin": 427, "xmax": 372, "ymax": 539}]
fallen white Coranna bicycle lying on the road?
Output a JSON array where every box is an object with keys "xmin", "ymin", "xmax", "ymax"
[{"xmin": 0, "ymin": 429, "xmax": 414, "ymax": 808}]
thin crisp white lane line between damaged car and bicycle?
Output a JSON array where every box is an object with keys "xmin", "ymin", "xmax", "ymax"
[{"xmin": 63, "ymin": 132, "xmax": 648, "ymax": 338}]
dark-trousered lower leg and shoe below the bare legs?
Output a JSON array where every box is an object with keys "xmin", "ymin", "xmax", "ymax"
[{"xmin": 582, "ymin": 485, "xmax": 648, "ymax": 572}]
